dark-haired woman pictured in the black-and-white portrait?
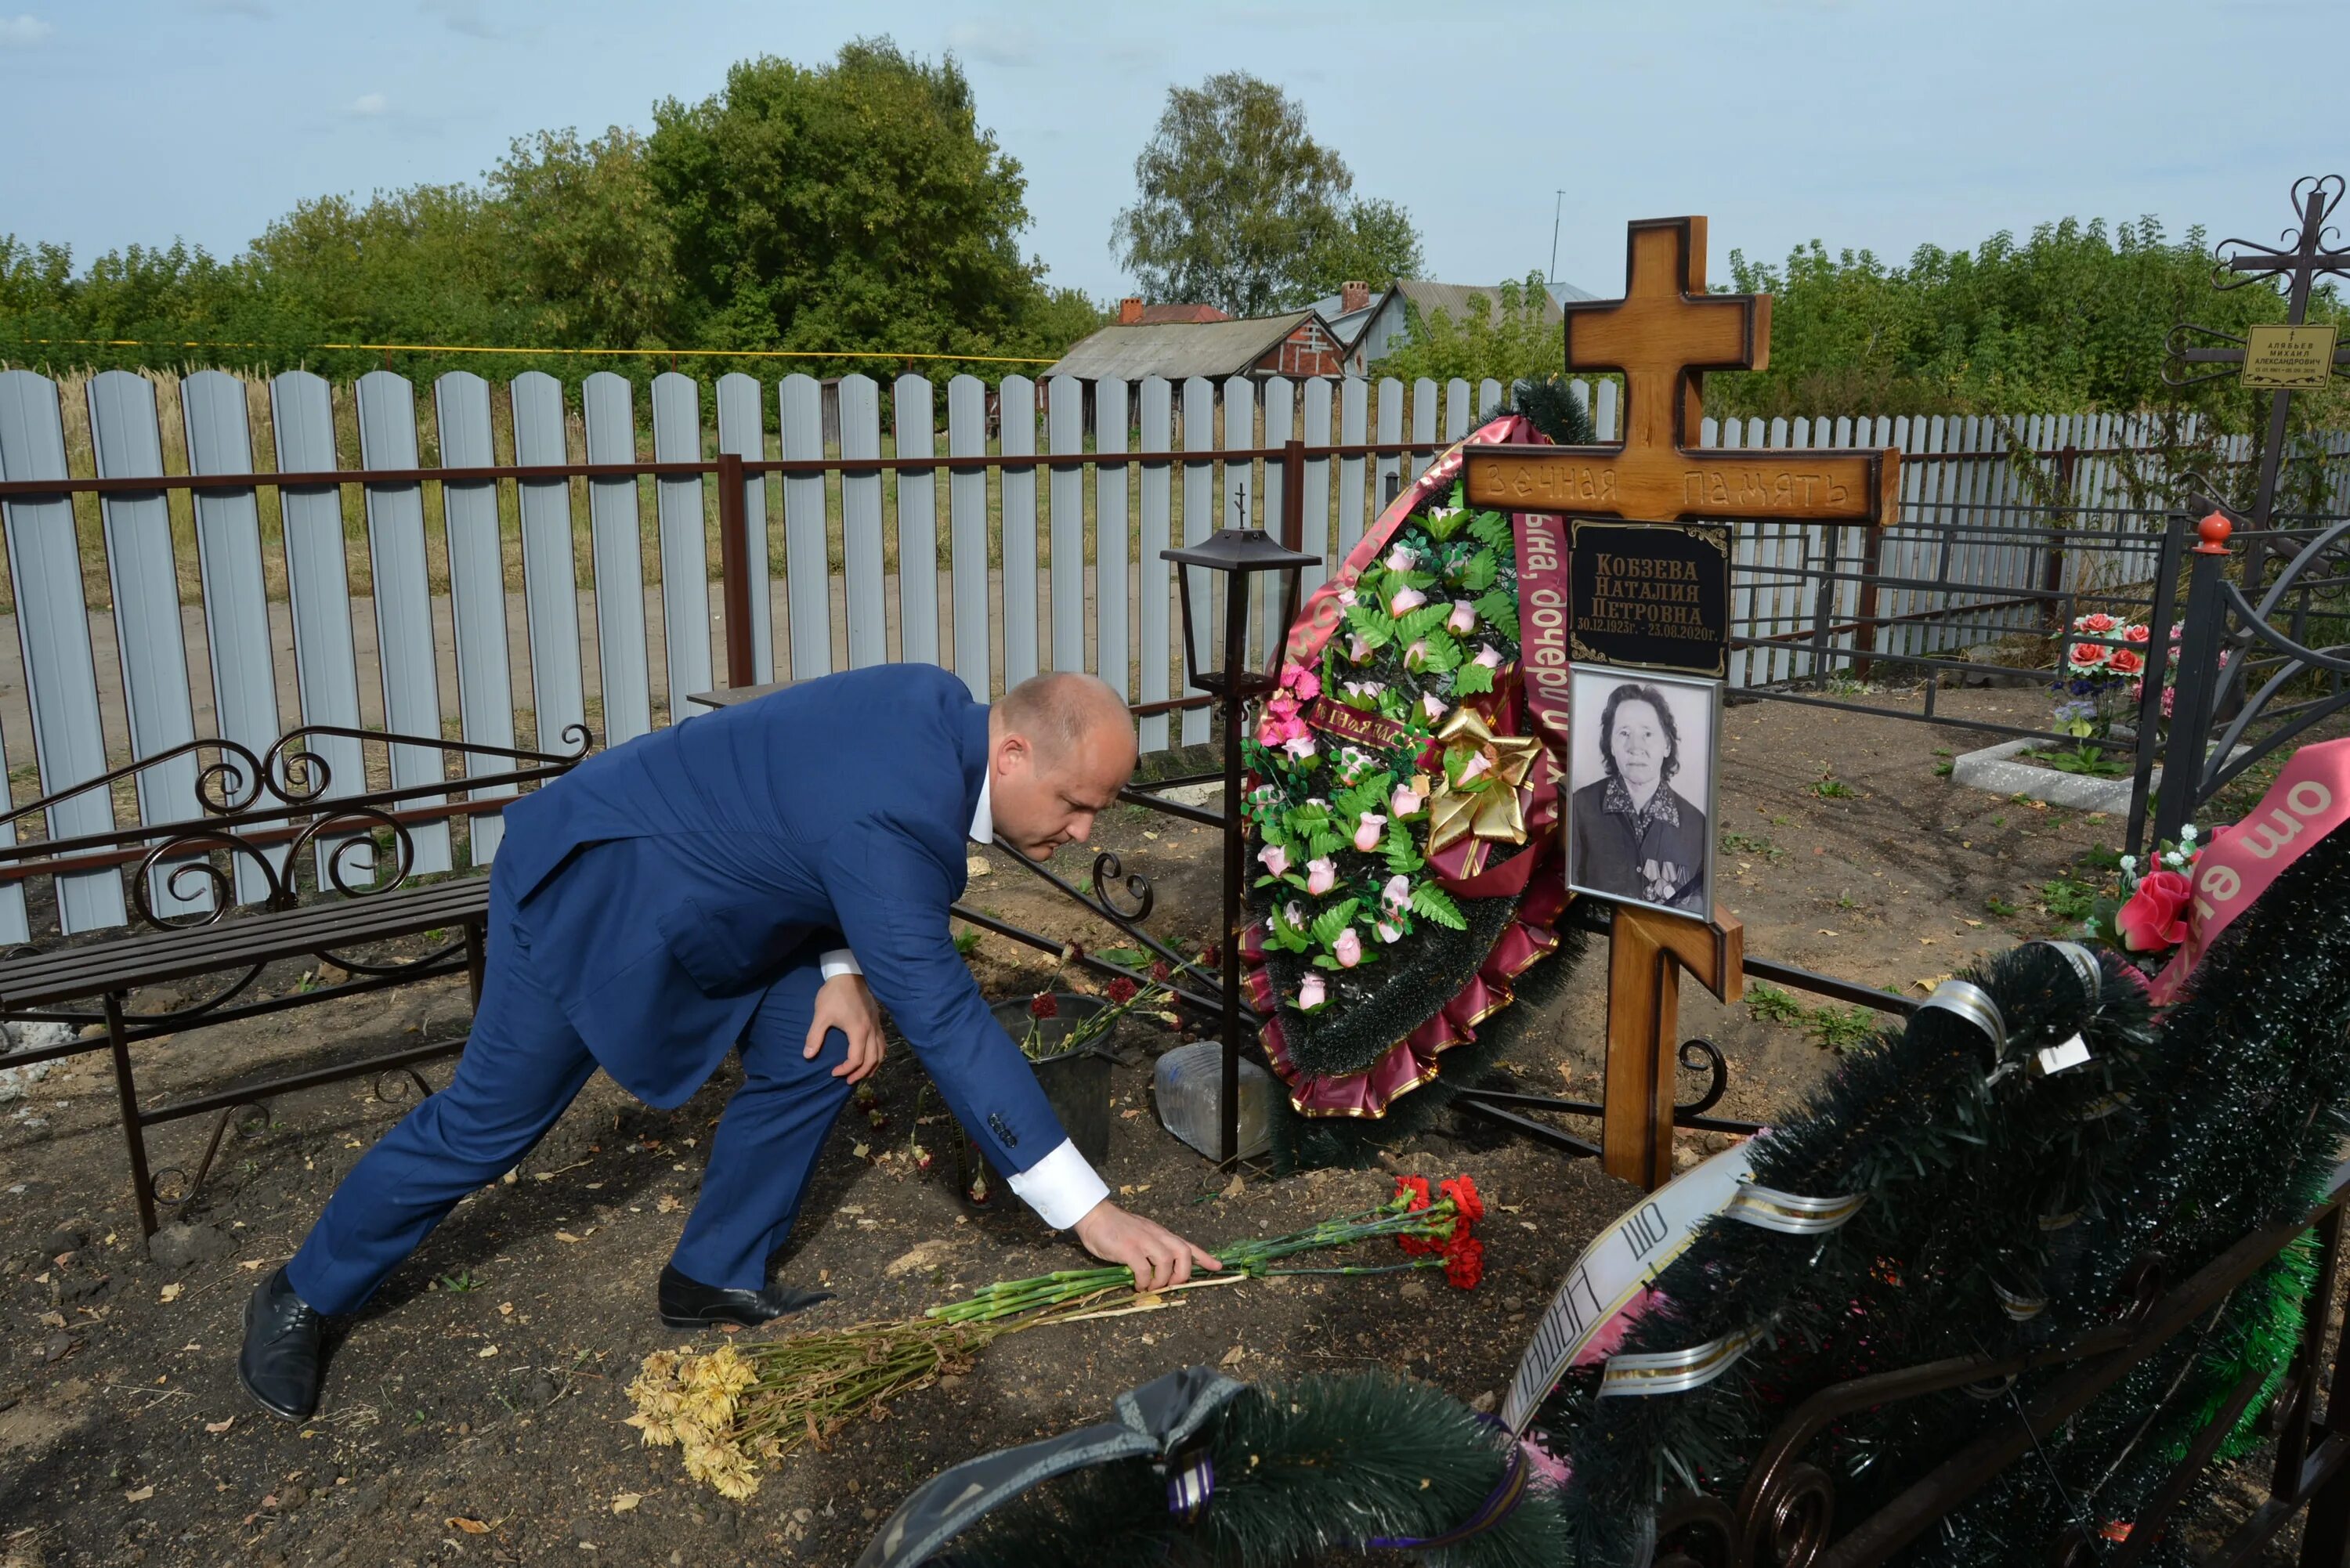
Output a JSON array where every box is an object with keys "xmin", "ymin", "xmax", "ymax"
[{"xmin": 1570, "ymin": 681, "xmax": 1706, "ymax": 915}]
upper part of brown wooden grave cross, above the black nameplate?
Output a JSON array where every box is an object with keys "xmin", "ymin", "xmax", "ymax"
[{"xmin": 1466, "ymin": 219, "xmax": 1901, "ymax": 524}]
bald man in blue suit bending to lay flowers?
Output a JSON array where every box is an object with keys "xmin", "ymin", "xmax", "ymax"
[{"xmin": 237, "ymin": 665, "xmax": 1217, "ymax": 1420}]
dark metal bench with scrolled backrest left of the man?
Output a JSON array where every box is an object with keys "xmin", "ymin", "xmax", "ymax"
[{"xmin": 0, "ymin": 724, "xmax": 590, "ymax": 1234}]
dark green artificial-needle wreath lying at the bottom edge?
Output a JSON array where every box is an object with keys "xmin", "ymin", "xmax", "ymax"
[{"xmin": 935, "ymin": 1373, "xmax": 1567, "ymax": 1568}]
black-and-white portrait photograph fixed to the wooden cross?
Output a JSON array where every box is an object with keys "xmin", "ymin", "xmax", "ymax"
[{"xmin": 1567, "ymin": 665, "xmax": 1723, "ymax": 919}]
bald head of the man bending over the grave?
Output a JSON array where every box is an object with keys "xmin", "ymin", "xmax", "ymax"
[{"xmin": 987, "ymin": 670, "xmax": 1135, "ymax": 861}]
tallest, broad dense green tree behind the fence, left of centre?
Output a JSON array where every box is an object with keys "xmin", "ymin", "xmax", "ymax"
[{"xmin": 646, "ymin": 40, "xmax": 1046, "ymax": 369}]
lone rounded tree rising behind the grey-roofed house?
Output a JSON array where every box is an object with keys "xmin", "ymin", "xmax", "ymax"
[{"xmin": 1112, "ymin": 70, "xmax": 1419, "ymax": 315}]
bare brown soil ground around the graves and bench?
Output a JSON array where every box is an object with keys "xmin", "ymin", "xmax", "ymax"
[{"xmin": 0, "ymin": 691, "xmax": 2153, "ymax": 1568}]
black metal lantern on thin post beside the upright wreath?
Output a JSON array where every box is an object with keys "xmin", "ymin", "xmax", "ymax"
[{"xmin": 1161, "ymin": 529, "xmax": 1321, "ymax": 1164}]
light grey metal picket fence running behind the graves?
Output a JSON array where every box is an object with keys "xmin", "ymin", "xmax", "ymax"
[{"xmin": 0, "ymin": 371, "xmax": 2350, "ymax": 943}]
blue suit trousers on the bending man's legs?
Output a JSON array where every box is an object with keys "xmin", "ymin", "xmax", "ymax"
[{"xmin": 287, "ymin": 870, "xmax": 848, "ymax": 1314}]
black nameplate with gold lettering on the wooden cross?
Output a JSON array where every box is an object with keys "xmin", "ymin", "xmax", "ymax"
[{"xmin": 1567, "ymin": 517, "xmax": 1730, "ymax": 679}]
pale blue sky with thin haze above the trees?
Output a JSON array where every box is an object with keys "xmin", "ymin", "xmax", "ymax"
[{"xmin": 0, "ymin": 0, "xmax": 2350, "ymax": 310}]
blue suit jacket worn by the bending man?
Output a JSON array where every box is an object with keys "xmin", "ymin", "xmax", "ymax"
[{"xmin": 494, "ymin": 665, "xmax": 1062, "ymax": 1173}]
